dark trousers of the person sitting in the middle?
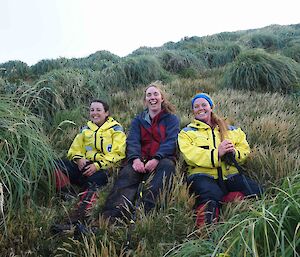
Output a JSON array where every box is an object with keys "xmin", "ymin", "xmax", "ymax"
[{"xmin": 103, "ymin": 159, "xmax": 175, "ymax": 218}]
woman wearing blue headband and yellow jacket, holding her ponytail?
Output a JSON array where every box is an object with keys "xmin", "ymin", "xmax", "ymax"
[{"xmin": 178, "ymin": 93, "xmax": 262, "ymax": 226}]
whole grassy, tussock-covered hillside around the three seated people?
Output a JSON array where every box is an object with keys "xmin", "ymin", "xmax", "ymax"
[{"xmin": 0, "ymin": 24, "xmax": 300, "ymax": 257}]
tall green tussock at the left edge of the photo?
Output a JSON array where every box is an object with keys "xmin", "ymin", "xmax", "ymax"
[{"xmin": 0, "ymin": 97, "xmax": 55, "ymax": 212}]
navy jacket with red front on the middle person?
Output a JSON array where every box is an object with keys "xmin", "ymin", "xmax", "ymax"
[{"xmin": 126, "ymin": 109, "xmax": 179, "ymax": 162}]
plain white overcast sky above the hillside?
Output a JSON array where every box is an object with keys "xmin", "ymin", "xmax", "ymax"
[{"xmin": 0, "ymin": 0, "xmax": 300, "ymax": 65}]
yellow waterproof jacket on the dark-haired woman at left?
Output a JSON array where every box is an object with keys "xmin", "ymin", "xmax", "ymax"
[{"xmin": 68, "ymin": 117, "xmax": 126, "ymax": 170}]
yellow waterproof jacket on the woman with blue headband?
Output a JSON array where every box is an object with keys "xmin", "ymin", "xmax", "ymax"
[{"xmin": 178, "ymin": 119, "xmax": 250, "ymax": 179}]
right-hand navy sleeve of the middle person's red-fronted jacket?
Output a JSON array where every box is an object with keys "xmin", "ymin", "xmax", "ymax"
[{"xmin": 154, "ymin": 114, "xmax": 179, "ymax": 160}]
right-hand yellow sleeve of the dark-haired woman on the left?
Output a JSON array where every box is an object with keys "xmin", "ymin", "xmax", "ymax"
[{"xmin": 94, "ymin": 126, "xmax": 126, "ymax": 170}]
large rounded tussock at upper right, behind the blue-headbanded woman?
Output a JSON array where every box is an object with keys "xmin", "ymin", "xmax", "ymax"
[{"xmin": 223, "ymin": 50, "xmax": 299, "ymax": 93}]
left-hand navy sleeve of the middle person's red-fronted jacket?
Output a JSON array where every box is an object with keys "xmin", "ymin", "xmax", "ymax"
[{"xmin": 126, "ymin": 118, "xmax": 142, "ymax": 161}]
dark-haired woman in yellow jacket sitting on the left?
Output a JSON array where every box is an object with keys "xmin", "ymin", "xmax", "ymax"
[{"xmin": 53, "ymin": 100, "xmax": 126, "ymax": 231}]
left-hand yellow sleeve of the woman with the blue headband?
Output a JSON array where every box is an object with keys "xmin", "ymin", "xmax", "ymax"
[{"xmin": 178, "ymin": 130, "xmax": 219, "ymax": 168}]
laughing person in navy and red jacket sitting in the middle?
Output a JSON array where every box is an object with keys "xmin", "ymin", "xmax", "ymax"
[{"xmin": 103, "ymin": 82, "xmax": 179, "ymax": 222}]
